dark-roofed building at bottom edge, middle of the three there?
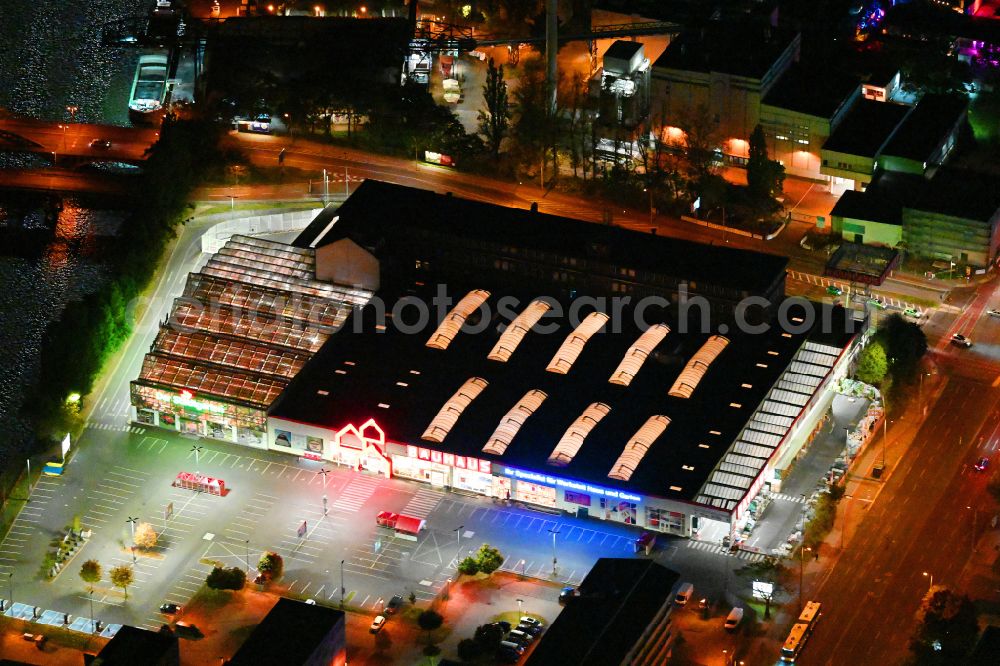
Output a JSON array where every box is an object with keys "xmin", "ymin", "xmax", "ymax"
[{"xmin": 226, "ymin": 597, "xmax": 347, "ymax": 666}]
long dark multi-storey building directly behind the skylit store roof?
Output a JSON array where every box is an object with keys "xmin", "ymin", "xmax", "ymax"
[{"xmin": 295, "ymin": 180, "xmax": 787, "ymax": 314}]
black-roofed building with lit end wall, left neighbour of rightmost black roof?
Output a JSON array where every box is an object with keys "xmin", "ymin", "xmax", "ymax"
[{"xmin": 820, "ymin": 99, "xmax": 912, "ymax": 189}]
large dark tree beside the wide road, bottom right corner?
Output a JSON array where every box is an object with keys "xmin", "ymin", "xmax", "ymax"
[{"xmin": 910, "ymin": 585, "xmax": 979, "ymax": 665}]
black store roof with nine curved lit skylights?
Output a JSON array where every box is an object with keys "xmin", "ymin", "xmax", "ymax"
[{"xmin": 270, "ymin": 278, "xmax": 850, "ymax": 509}]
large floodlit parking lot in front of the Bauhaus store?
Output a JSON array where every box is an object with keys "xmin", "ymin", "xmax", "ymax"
[{"xmin": 0, "ymin": 418, "xmax": 772, "ymax": 640}]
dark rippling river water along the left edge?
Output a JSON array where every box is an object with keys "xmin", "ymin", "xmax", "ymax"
[{"xmin": 0, "ymin": 0, "xmax": 153, "ymax": 468}]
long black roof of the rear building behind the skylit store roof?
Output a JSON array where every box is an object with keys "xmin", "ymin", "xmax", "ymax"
[{"xmin": 294, "ymin": 179, "xmax": 788, "ymax": 292}]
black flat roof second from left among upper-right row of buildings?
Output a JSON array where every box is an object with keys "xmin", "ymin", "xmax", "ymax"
[{"xmin": 762, "ymin": 64, "xmax": 861, "ymax": 120}]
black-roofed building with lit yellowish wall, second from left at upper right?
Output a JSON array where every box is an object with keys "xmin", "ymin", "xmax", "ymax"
[{"xmin": 760, "ymin": 64, "xmax": 860, "ymax": 178}]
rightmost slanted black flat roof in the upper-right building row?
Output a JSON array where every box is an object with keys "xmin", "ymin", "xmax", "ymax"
[{"xmin": 882, "ymin": 94, "xmax": 969, "ymax": 162}]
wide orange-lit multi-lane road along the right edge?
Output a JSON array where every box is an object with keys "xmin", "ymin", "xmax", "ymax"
[{"xmin": 799, "ymin": 274, "xmax": 1000, "ymax": 666}]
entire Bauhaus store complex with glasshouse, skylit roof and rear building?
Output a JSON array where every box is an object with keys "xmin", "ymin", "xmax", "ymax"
[{"xmin": 133, "ymin": 181, "xmax": 859, "ymax": 536}]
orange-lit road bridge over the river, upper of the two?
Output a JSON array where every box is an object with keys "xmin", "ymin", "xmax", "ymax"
[{"xmin": 0, "ymin": 117, "xmax": 159, "ymax": 167}]
